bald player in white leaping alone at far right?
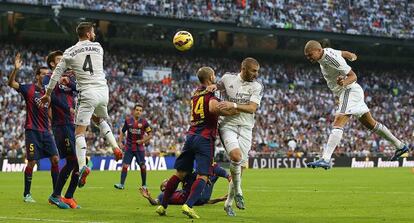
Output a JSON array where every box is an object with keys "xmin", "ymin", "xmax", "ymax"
[{"xmin": 304, "ymin": 40, "xmax": 408, "ymax": 169}]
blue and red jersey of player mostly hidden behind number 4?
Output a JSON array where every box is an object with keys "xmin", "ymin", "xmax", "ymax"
[{"xmin": 43, "ymin": 73, "xmax": 76, "ymax": 126}]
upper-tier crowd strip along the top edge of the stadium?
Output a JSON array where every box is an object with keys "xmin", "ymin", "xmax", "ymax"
[{"xmin": 6, "ymin": 0, "xmax": 414, "ymax": 38}]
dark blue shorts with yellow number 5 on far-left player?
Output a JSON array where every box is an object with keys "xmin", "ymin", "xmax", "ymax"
[{"xmin": 24, "ymin": 129, "xmax": 58, "ymax": 161}]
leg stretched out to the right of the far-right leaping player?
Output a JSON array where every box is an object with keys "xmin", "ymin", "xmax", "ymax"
[{"xmin": 359, "ymin": 112, "xmax": 408, "ymax": 161}]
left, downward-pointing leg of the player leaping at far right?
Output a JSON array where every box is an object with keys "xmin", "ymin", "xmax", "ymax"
[{"xmin": 306, "ymin": 114, "xmax": 351, "ymax": 169}]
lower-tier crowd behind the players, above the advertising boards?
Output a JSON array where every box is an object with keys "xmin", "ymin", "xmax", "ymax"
[{"xmin": 0, "ymin": 41, "xmax": 414, "ymax": 161}]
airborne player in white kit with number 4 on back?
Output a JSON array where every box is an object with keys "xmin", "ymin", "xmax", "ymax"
[{"xmin": 40, "ymin": 22, "xmax": 122, "ymax": 187}]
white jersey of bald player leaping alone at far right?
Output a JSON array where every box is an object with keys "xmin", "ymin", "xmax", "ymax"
[{"xmin": 318, "ymin": 48, "xmax": 352, "ymax": 96}]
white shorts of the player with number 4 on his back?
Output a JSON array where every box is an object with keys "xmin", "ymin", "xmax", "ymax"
[{"xmin": 75, "ymin": 88, "xmax": 109, "ymax": 126}]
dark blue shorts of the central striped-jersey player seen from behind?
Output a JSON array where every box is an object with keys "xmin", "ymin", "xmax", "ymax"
[{"xmin": 174, "ymin": 135, "xmax": 214, "ymax": 176}]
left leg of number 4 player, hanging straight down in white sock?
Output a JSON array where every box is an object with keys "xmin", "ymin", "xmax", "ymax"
[{"xmin": 75, "ymin": 125, "xmax": 91, "ymax": 187}]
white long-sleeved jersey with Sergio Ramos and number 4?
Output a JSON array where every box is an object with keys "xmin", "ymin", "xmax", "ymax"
[{"xmin": 48, "ymin": 40, "xmax": 107, "ymax": 91}]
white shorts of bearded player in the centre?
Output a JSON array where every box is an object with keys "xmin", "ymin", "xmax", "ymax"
[{"xmin": 219, "ymin": 126, "xmax": 253, "ymax": 166}]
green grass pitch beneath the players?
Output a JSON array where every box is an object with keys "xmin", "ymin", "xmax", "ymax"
[{"xmin": 0, "ymin": 168, "xmax": 414, "ymax": 223}]
